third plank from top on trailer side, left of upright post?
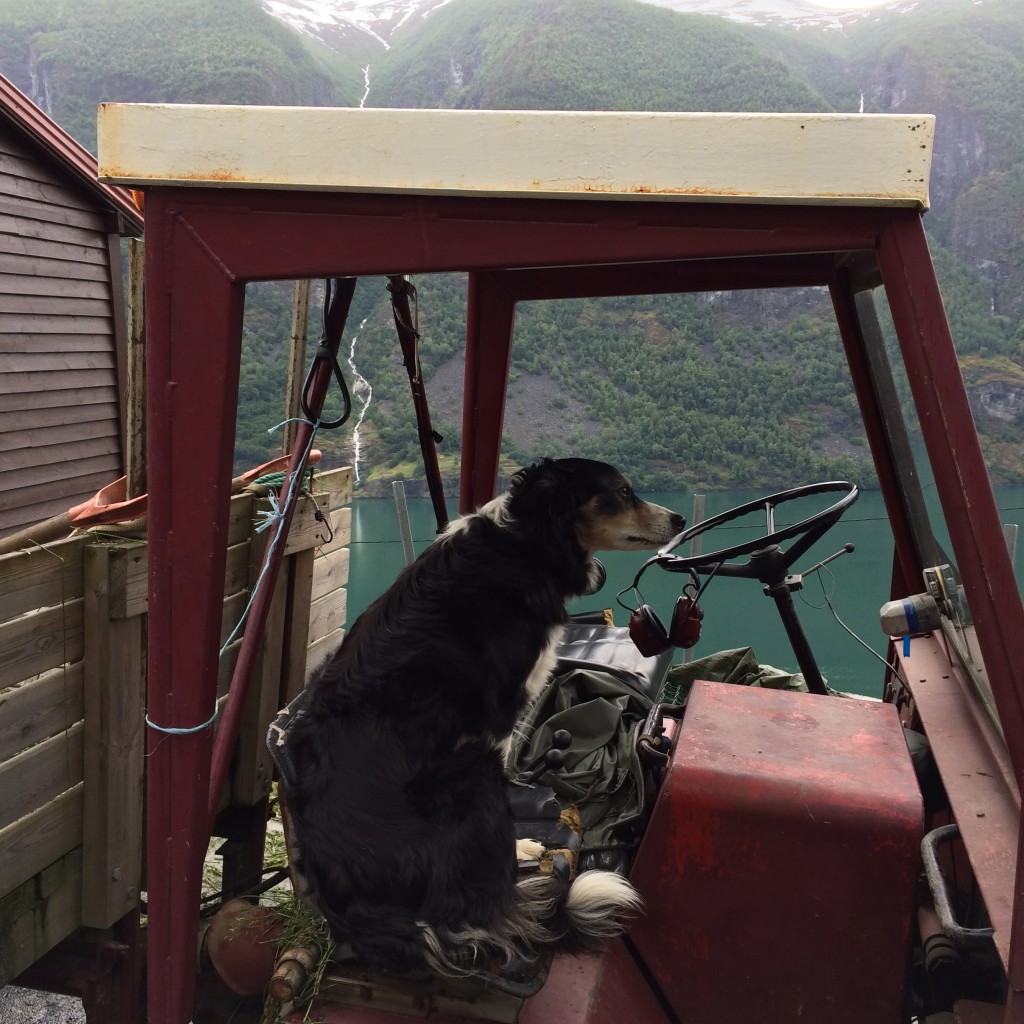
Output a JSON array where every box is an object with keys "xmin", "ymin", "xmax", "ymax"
[{"xmin": 0, "ymin": 662, "xmax": 85, "ymax": 763}]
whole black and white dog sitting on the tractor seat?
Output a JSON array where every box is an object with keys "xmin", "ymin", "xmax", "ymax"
[{"xmin": 287, "ymin": 459, "xmax": 683, "ymax": 975}]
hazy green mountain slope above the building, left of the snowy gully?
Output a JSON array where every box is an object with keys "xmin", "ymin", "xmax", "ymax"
[{"xmin": 0, "ymin": 0, "xmax": 362, "ymax": 150}]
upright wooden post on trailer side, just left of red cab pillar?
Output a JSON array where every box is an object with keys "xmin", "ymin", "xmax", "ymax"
[{"xmin": 82, "ymin": 544, "xmax": 145, "ymax": 928}]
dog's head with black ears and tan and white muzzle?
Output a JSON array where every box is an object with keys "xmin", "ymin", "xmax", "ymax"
[{"xmin": 507, "ymin": 459, "xmax": 685, "ymax": 559}]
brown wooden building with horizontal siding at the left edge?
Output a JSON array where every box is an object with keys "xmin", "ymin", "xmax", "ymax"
[{"xmin": 0, "ymin": 76, "xmax": 142, "ymax": 537}]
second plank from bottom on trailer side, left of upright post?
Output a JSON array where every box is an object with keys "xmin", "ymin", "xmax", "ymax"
[{"xmin": 0, "ymin": 782, "xmax": 85, "ymax": 901}]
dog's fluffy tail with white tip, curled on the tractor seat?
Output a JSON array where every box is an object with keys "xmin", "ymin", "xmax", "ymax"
[{"xmin": 423, "ymin": 870, "xmax": 643, "ymax": 976}]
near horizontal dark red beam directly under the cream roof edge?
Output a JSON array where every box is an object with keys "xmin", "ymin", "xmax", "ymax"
[{"xmin": 149, "ymin": 188, "xmax": 885, "ymax": 284}]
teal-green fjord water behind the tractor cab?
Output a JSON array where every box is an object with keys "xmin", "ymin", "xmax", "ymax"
[{"xmin": 346, "ymin": 487, "xmax": 1024, "ymax": 696}]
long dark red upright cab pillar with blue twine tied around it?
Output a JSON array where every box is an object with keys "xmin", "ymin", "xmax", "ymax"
[{"xmin": 145, "ymin": 189, "xmax": 243, "ymax": 1024}]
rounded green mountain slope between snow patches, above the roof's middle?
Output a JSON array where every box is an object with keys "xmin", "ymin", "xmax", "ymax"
[{"xmin": 371, "ymin": 0, "xmax": 828, "ymax": 111}]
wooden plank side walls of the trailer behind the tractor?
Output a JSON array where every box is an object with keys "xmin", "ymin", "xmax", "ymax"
[{"xmin": 0, "ymin": 469, "xmax": 351, "ymax": 985}]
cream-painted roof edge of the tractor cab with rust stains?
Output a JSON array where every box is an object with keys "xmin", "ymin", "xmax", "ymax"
[{"xmin": 97, "ymin": 103, "xmax": 935, "ymax": 210}]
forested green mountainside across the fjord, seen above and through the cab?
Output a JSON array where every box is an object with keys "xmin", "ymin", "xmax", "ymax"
[{"xmin": 0, "ymin": 0, "xmax": 1024, "ymax": 489}]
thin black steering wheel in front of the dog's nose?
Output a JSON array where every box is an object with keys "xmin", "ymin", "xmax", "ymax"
[{"xmin": 648, "ymin": 480, "xmax": 860, "ymax": 584}]
